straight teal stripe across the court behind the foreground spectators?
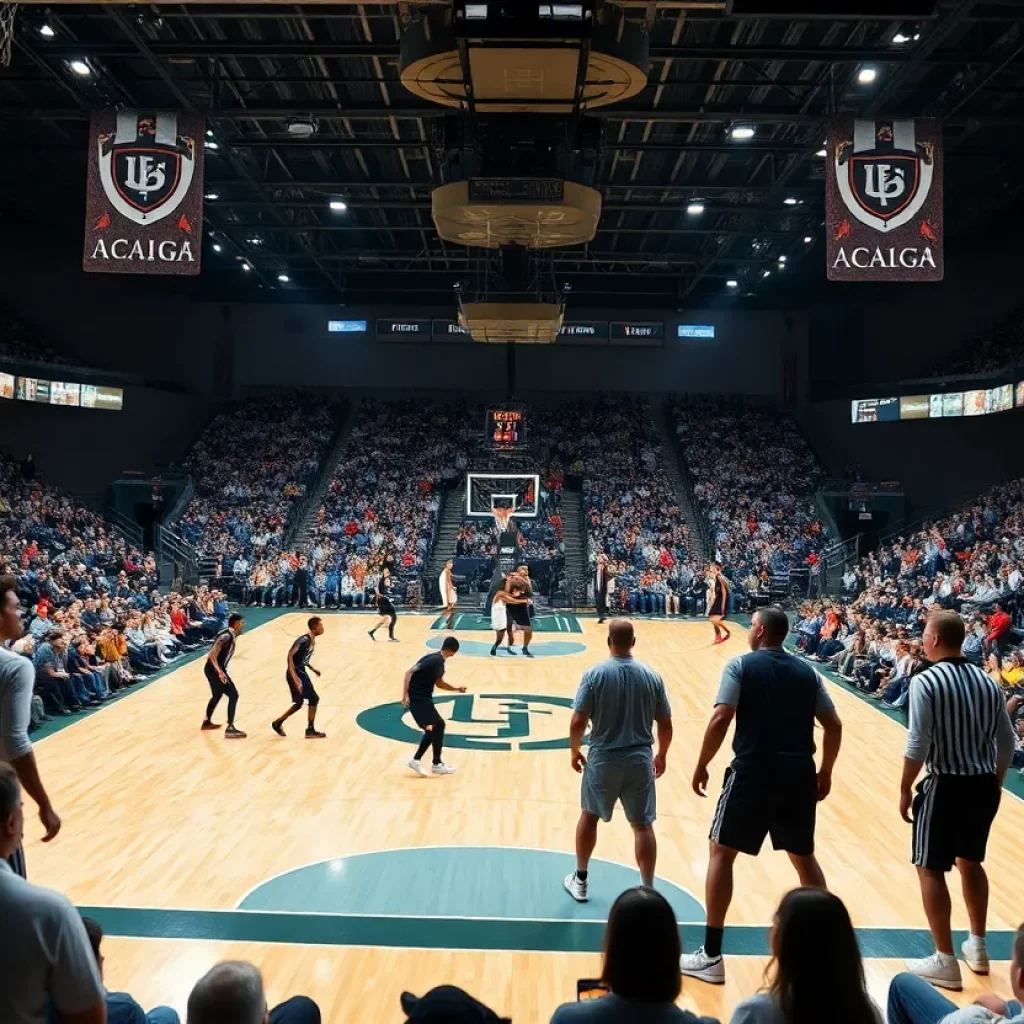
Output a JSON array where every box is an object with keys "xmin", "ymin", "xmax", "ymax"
[{"xmin": 79, "ymin": 909, "xmax": 1017, "ymax": 961}]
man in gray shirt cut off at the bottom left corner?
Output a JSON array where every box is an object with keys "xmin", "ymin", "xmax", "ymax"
[{"xmin": 0, "ymin": 762, "xmax": 106, "ymax": 1024}]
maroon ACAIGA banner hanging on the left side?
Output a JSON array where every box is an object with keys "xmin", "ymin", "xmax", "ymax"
[{"xmin": 82, "ymin": 111, "xmax": 205, "ymax": 274}]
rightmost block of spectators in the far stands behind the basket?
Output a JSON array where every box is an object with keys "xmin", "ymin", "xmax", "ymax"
[{"xmin": 674, "ymin": 397, "xmax": 825, "ymax": 591}]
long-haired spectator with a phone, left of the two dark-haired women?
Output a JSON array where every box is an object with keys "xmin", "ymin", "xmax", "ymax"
[{"xmin": 551, "ymin": 886, "xmax": 720, "ymax": 1024}]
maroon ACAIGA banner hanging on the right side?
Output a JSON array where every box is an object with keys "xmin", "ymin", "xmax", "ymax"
[{"xmin": 825, "ymin": 117, "xmax": 943, "ymax": 281}]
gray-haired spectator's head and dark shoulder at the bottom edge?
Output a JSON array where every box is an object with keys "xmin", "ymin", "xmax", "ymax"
[{"xmin": 187, "ymin": 961, "xmax": 321, "ymax": 1024}]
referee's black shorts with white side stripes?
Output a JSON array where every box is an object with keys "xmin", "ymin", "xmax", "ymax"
[{"xmin": 911, "ymin": 775, "xmax": 1002, "ymax": 871}]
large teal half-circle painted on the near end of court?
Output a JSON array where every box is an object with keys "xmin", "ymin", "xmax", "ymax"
[{"xmin": 238, "ymin": 846, "xmax": 705, "ymax": 924}]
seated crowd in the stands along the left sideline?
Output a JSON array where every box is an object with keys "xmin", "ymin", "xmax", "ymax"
[{"xmin": 0, "ymin": 457, "xmax": 227, "ymax": 725}]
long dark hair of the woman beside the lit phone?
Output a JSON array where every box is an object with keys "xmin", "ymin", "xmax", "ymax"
[{"xmin": 601, "ymin": 886, "xmax": 682, "ymax": 1002}]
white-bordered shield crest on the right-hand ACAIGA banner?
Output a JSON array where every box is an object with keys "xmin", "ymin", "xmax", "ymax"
[{"xmin": 834, "ymin": 121, "xmax": 934, "ymax": 231}]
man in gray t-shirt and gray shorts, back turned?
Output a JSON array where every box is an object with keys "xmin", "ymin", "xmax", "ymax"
[{"xmin": 564, "ymin": 618, "xmax": 672, "ymax": 903}]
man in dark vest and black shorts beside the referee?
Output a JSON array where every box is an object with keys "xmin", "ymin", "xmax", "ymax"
[{"xmin": 679, "ymin": 608, "xmax": 843, "ymax": 985}]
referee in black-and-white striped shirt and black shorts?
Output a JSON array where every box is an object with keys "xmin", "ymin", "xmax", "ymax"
[{"xmin": 899, "ymin": 611, "xmax": 1014, "ymax": 990}]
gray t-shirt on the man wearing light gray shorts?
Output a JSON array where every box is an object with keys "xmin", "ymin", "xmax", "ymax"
[{"xmin": 572, "ymin": 657, "xmax": 672, "ymax": 754}]
